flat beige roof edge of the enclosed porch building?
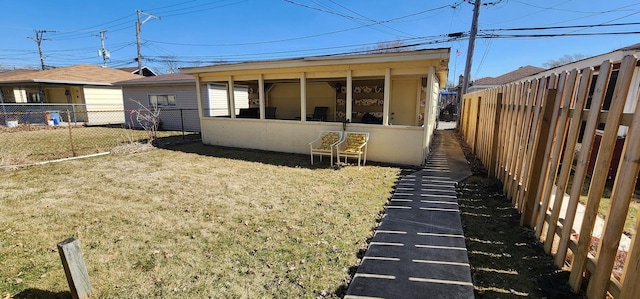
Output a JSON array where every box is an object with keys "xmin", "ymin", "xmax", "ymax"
[{"xmin": 180, "ymin": 48, "xmax": 450, "ymax": 83}]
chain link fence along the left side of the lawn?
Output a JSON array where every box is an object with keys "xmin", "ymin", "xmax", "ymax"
[{"xmin": 0, "ymin": 104, "xmax": 200, "ymax": 169}]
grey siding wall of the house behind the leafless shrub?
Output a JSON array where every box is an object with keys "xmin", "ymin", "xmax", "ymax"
[{"xmin": 122, "ymin": 84, "xmax": 207, "ymax": 132}]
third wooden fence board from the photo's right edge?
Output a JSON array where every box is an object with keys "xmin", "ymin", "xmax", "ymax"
[{"xmin": 556, "ymin": 60, "xmax": 612, "ymax": 275}]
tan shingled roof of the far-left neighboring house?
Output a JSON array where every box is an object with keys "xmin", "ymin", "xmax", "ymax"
[{"xmin": 0, "ymin": 64, "xmax": 141, "ymax": 86}]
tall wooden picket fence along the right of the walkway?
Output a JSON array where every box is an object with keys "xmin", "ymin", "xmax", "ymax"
[{"xmin": 460, "ymin": 56, "xmax": 640, "ymax": 299}]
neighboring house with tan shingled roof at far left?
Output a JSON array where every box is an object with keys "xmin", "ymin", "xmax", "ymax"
[{"xmin": 0, "ymin": 64, "xmax": 140, "ymax": 125}]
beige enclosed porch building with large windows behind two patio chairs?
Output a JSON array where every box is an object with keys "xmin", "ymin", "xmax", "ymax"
[{"xmin": 181, "ymin": 48, "xmax": 450, "ymax": 165}]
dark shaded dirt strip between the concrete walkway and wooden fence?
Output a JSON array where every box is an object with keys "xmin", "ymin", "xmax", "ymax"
[{"xmin": 458, "ymin": 134, "xmax": 558, "ymax": 298}]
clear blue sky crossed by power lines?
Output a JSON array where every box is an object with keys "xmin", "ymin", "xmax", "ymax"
[{"xmin": 0, "ymin": 0, "xmax": 640, "ymax": 82}]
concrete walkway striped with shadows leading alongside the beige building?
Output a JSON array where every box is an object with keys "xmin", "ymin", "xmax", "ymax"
[{"xmin": 345, "ymin": 131, "xmax": 474, "ymax": 298}]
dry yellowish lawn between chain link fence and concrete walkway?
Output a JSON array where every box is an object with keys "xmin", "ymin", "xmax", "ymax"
[{"xmin": 0, "ymin": 144, "xmax": 401, "ymax": 298}]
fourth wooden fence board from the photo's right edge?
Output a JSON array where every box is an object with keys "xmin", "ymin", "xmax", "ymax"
[{"xmin": 544, "ymin": 68, "xmax": 593, "ymax": 258}]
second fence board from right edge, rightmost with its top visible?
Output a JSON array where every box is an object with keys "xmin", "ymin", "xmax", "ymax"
[{"xmin": 569, "ymin": 56, "xmax": 635, "ymax": 290}]
